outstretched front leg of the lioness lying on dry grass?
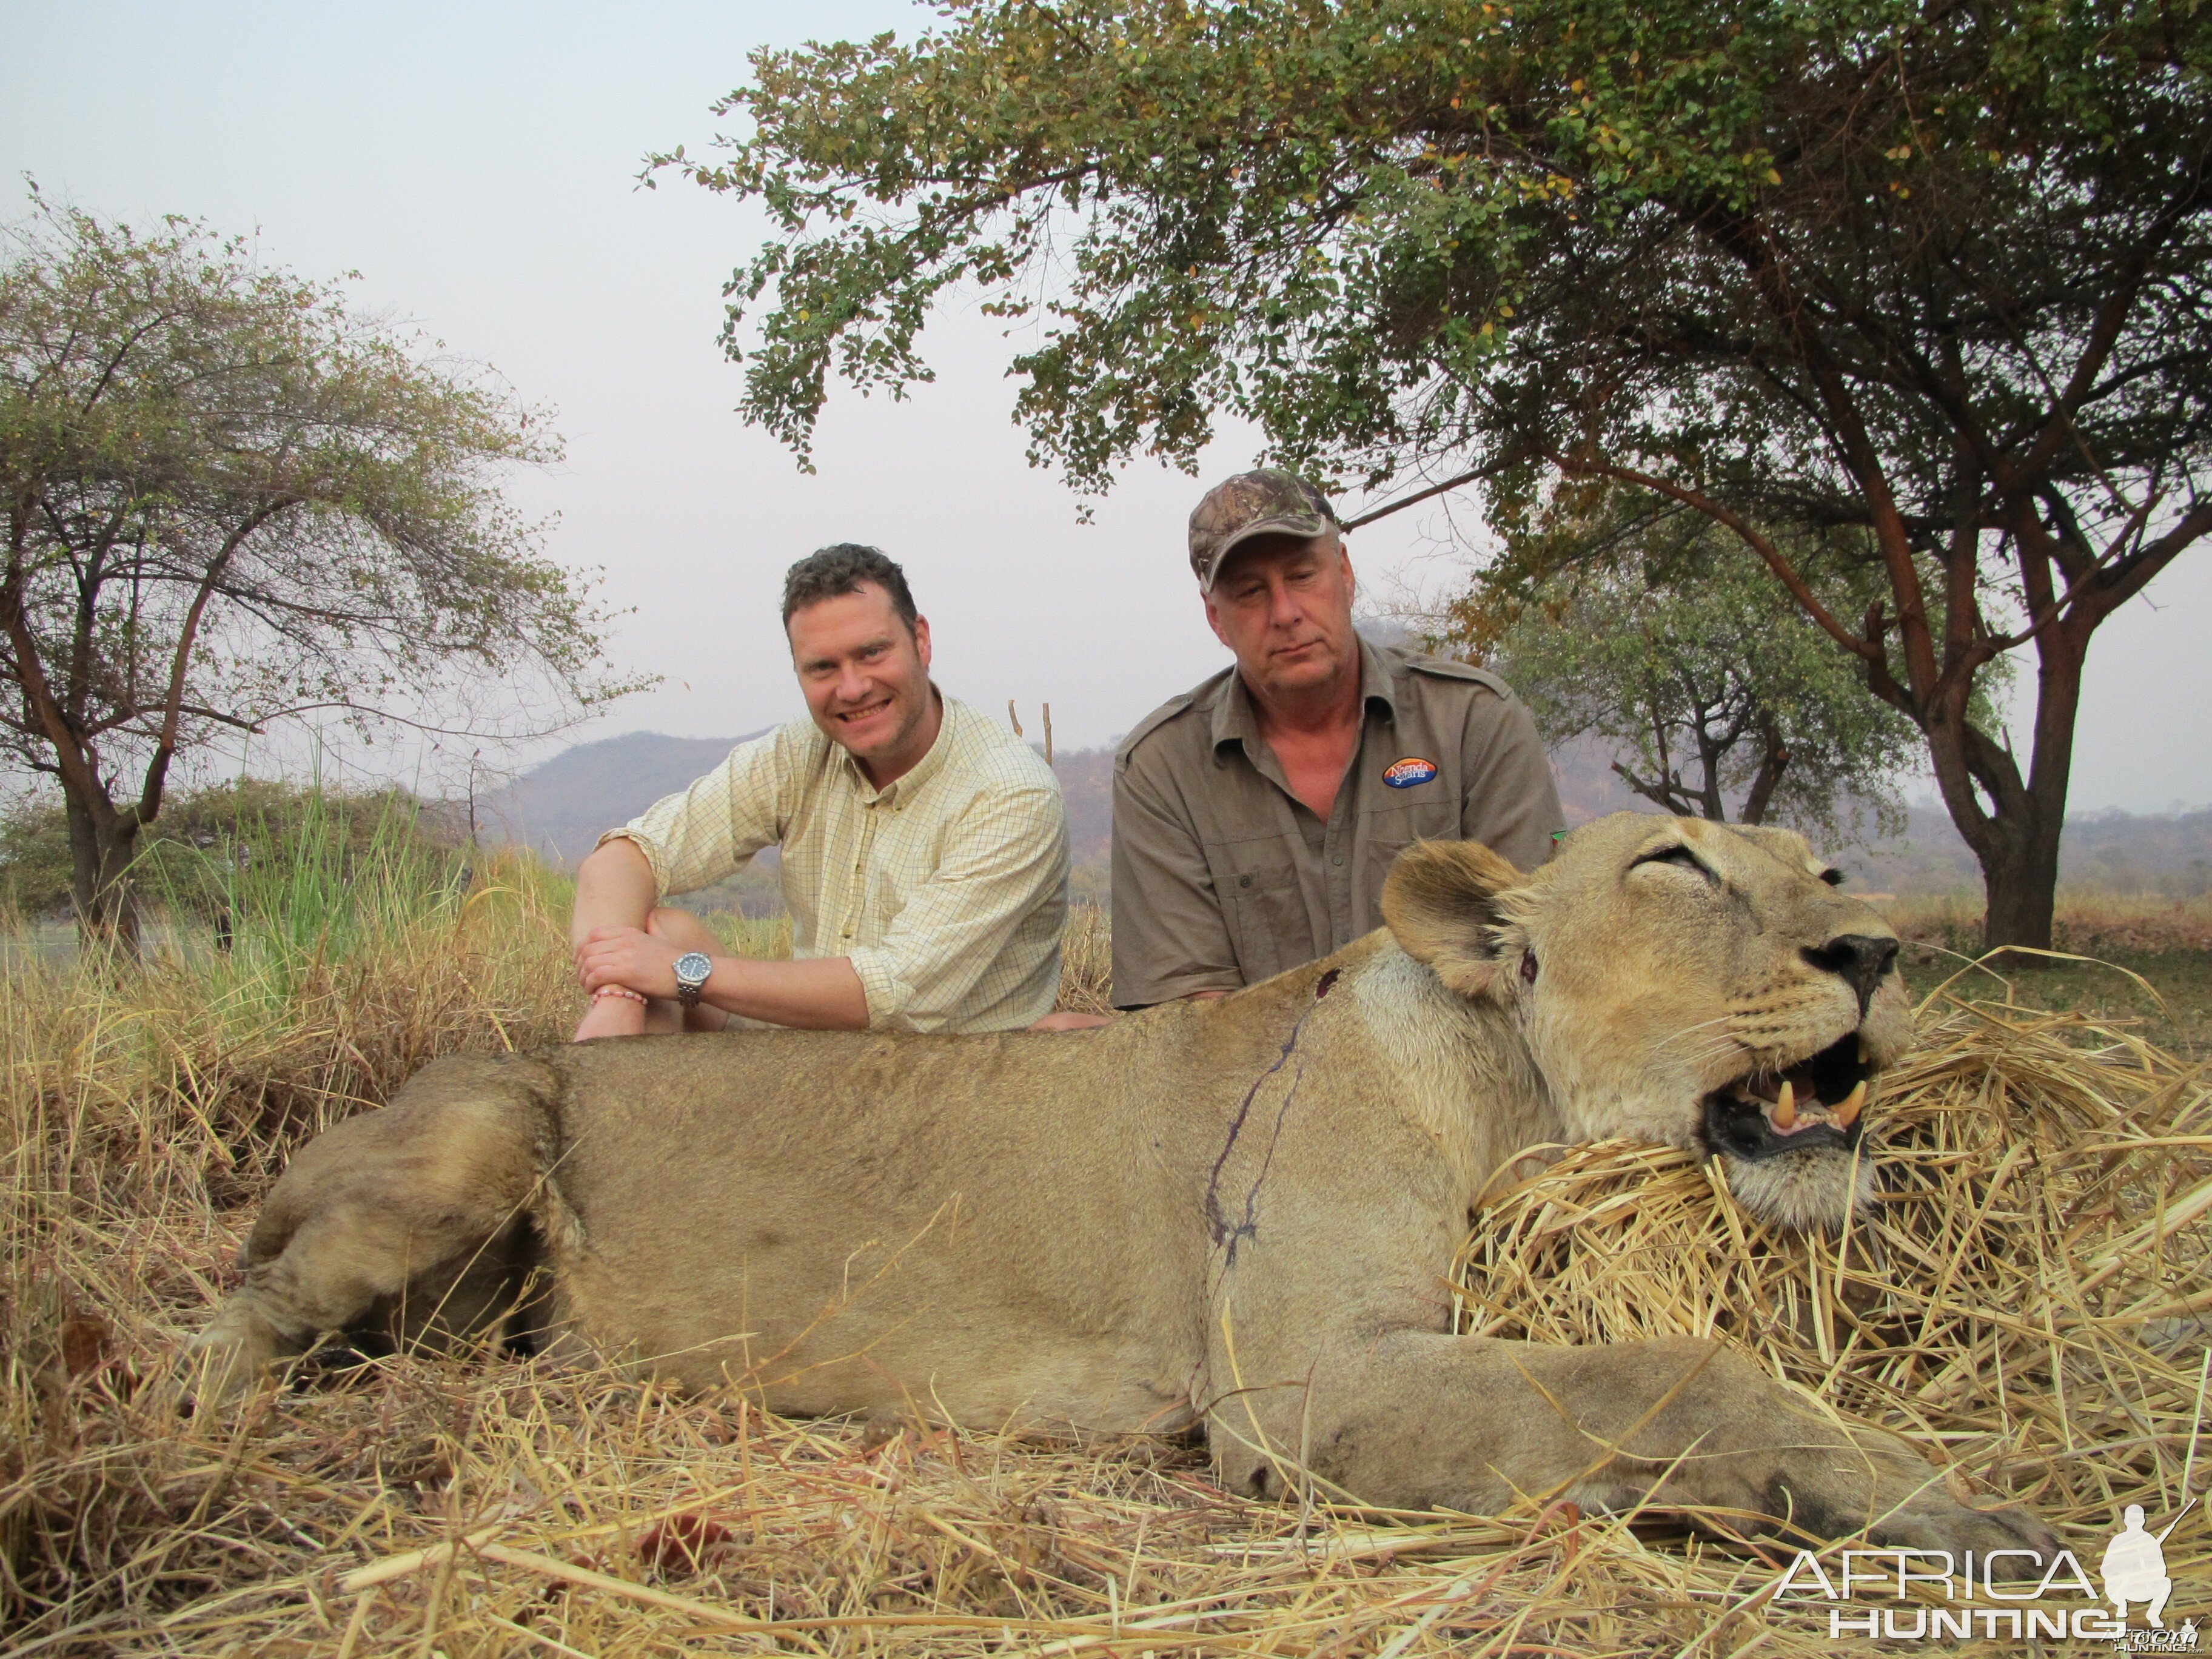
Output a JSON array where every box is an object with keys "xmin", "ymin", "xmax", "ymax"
[{"xmin": 1216, "ymin": 1329, "xmax": 2059, "ymax": 1577}]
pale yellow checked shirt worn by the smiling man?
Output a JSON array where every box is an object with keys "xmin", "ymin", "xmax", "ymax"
[{"xmin": 600, "ymin": 697, "xmax": 1068, "ymax": 1031}]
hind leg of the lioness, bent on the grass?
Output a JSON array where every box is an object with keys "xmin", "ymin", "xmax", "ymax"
[{"xmin": 190, "ymin": 1055, "xmax": 557, "ymax": 1398}]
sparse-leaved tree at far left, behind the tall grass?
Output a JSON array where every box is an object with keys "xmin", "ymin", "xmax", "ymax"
[{"xmin": 0, "ymin": 199, "xmax": 624, "ymax": 945}]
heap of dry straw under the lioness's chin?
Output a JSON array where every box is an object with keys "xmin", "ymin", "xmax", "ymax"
[{"xmin": 1462, "ymin": 1004, "xmax": 2212, "ymax": 1570}]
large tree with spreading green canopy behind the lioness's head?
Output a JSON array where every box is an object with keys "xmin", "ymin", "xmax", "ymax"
[{"xmin": 662, "ymin": 0, "xmax": 2212, "ymax": 945}]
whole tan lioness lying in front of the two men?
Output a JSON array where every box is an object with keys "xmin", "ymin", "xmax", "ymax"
[{"xmin": 201, "ymin": 814, "xmax": 2057, "ymax": 1570}]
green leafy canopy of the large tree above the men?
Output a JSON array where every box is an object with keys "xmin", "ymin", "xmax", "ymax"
[{"xmin": 662, "ymin": 0, "xmax": 2208, "ymax": 487}]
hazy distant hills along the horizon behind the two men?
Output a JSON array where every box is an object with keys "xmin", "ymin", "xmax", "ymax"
[{"xmin": 478, "ymin": 732, "xmax": 2212, "ymax": 911}]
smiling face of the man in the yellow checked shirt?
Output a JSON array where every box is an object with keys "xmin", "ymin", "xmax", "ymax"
[{"xmin": 788, "ymin": 581, "xmax": 931, "ymax": 774}]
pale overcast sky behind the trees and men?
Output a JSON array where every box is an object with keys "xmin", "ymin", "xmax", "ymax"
[{"xmin": 0, "ymin": 0, "xmax": 2212, "ymax": 812}]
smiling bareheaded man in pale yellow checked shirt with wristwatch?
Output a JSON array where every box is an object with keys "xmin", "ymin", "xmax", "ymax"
[{"xmin": 571, "ymin": 544, "xmax": 1068, "ymax": 1040}]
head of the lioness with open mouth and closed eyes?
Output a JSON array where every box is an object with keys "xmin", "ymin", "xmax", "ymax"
[{"xmin": 1382, "ymin": 812, "xmax": 1911, "ymax": 1228}]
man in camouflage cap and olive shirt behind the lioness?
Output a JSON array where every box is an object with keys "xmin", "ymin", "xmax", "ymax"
[{"xmin": 1113, "ymin": 469, "xmax": 1561, "ymax": 1008}]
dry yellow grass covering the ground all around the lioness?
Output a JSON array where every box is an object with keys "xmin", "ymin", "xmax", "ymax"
[{"xmin": 0, "ymin": 867, "xmax": 2212, "ymax": 1659}]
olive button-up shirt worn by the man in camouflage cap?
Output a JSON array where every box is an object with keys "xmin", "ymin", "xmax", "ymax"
[{"xmin": 1113, "ymin": 639, "xmax": 1561, "ymax": 1008}]
